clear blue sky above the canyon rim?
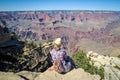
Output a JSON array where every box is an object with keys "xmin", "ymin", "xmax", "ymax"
[{"xmin": 0, "ymin": 0, "xmax": 120, "ymax": 11}]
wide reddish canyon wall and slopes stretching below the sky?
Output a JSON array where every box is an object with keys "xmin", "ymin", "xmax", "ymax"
[{"xmin": 0, "ymin": 11, "xmax": 120, "ymax": 56}]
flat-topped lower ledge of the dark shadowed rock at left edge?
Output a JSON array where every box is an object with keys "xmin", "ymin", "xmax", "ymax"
[{"xmin": 0, "ymin": 40, "xmax": 24, "ymax": 71}]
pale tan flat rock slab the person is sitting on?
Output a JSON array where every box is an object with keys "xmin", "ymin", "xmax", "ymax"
[{"xmin": 35, "ymin": 69, "xmax": 100, "ymax": 80}]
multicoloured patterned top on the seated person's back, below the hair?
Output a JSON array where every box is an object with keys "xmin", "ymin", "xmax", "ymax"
[{"xmin": 50, "ymin": 49, "xmax": 71, "ymax": 72}]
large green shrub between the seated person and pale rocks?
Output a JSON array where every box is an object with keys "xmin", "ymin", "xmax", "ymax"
[{"xmin": 73, "ymin": 51, "xmax": 104, "ymax": 79}]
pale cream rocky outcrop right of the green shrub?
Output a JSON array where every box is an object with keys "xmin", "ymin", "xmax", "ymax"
[{"xmin": 87, "ymin": 51, "xmax": 120, "ymax": 80}]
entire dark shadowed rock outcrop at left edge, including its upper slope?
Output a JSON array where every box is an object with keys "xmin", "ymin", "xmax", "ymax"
[{"xmin": 0, "ymin": 25, "xmax": 24, "ymax": 71}]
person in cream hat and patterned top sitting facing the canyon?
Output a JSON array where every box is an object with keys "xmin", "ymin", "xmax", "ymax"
[{"xmin": 49, "ymin": 38, "xmax": 72, "ymax": 73}]
